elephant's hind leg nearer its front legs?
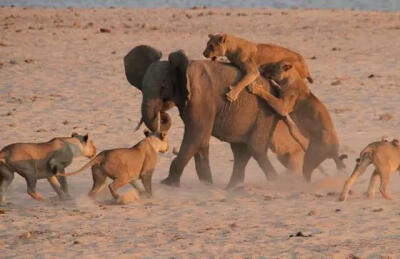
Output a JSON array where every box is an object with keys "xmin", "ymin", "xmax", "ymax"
[{"xmin": 226, "ymin": 144, "xmax": 251, "ymax": 189}]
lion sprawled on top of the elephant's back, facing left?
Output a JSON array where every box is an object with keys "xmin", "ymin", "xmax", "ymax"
[{"xmin": 203, "ymin": 34, "xmax": 313, "ymax": 102}]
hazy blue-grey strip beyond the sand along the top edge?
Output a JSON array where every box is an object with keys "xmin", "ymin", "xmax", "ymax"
[{"xmin": 0, "ymin": 0, "xmax": 400, "ymax": 11}]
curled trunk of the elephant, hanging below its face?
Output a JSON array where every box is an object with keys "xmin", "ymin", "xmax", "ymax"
[{"xmin": 142, "ymin": 100, "xmax": 171, "ymax": 132}]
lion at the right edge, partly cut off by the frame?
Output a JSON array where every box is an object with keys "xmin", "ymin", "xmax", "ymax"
[{"xmin": 339, "ymin": 139, "xmax": 400, "ymax": 201}]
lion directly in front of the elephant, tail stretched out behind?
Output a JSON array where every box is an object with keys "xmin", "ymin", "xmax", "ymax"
[{"xmin": 64, "ymin": 130, "xmax": 168, "ymax": 203}]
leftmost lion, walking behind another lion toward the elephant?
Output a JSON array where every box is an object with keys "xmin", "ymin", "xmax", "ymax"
[{"xmin": 0, "ymin": 133, "xmax": 96, "ymax": 202}]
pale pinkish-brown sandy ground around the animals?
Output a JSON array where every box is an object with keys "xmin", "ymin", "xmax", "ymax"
[{"xmin": 0, "ymin": 8, "xmax": 400, "ymax": 258}]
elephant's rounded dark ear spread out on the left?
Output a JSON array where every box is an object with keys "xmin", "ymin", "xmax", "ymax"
[{"xmin": 124, "ymin": 45, "xmax": 162, "ymax": 90}]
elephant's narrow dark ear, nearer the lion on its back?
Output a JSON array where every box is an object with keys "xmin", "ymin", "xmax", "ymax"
[{"xmin": 168, "ymin": 50, "xmax": 191, "ymax": 104}]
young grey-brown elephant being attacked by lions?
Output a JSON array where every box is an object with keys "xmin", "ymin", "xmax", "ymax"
[{"xmin": 124, "ymin": 45, "xmax": 300, "ymax": 188}]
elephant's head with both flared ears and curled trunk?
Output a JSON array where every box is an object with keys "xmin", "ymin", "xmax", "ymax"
[{"xmin": 124, "ymin": 45, "xmax": 190, "ymax": 131}]
